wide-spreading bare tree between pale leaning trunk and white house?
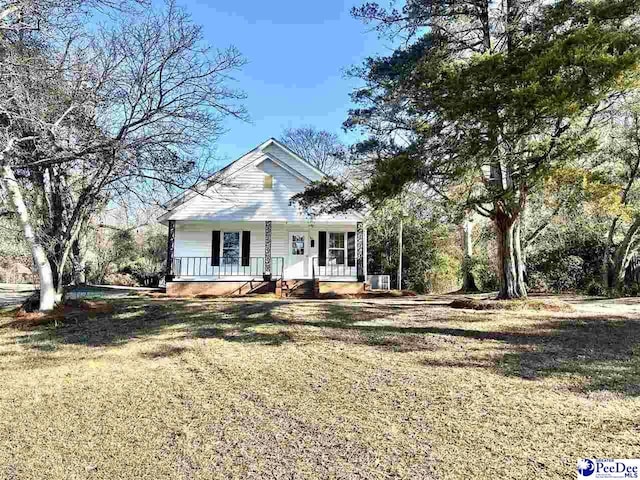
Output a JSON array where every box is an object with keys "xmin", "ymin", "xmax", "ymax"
[{"xmin": 3, "ymin": 3, "xmax": 245, "ymax": 308}]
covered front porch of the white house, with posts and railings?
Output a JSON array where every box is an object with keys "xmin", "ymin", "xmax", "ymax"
[{"xmin": 166, "ymin": 220, "xmax": 366, "ymax": 290}]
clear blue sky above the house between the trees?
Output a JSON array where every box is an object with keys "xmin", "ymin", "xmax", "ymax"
[{"xmin": 181, "ymin": 0, "xmax": 389, "ymax": 168}]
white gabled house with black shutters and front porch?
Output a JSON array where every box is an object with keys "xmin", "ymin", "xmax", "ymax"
[{"xmin": 159, "ymin": 138, "xmax": 367, "ymax": 294}]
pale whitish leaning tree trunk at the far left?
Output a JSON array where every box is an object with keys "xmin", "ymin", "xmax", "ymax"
[{"xmin": 2, "ymin": 165, "xmax": 56, "ymax": 311}]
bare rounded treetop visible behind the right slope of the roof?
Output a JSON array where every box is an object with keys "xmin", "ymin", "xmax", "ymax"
[{"xmin": 280, "ymin": 126, "xmax": 346, "ymax": 175}]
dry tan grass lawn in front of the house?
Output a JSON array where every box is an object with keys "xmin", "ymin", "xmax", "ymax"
[{"xmin": 0, "ymin": 297, "xmax": 640, "ymax": 479}]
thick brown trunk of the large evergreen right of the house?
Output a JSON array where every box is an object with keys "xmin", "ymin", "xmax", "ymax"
[{"xmin": 494, "ymin": 210, "xmax": 527, "ymax": 299}]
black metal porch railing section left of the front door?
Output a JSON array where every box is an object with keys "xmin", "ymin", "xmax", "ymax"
[{"xmin": 171, "ymin": 257, "xmax": 284, "ymax": 278}]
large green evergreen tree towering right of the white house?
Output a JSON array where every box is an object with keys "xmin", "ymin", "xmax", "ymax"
[{"xmin": 303, "ymin": 0, "xmax": 640, "ymax": 298}]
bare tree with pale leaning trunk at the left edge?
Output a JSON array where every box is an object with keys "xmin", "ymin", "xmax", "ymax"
[{"xmin": 0, "ymin": 0, "xmax": 146, "ymax": 310}]
